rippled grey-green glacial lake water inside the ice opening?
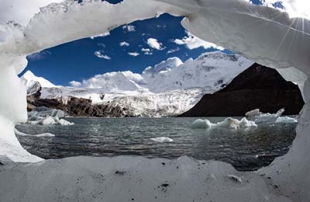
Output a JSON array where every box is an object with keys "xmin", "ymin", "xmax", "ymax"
[{"xmin": 16, "ymin": 117, "xmax": 297, "ymax": 171}]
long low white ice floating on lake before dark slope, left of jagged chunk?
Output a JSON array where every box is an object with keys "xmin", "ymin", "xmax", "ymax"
[{"xmin": 191, "ymin": 117, "xmax": 257, "ymax": 129}]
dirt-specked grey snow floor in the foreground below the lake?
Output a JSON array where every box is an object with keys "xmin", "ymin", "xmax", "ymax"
[{"xmin": 0, "ymin": 156, "xmax": 291, "ymax": 202}]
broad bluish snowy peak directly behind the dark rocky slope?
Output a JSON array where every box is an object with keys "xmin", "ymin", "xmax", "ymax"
[{"xmin": 142, "ymin": 52, "xmax": 253, "ymax": 93}]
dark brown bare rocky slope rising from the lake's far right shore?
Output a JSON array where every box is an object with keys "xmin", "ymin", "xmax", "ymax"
[{"xmin": 180, "ymin": 63, "xmax": 304, "ymax": 117}]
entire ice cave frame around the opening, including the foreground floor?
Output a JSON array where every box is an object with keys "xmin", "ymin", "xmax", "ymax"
[{"xmin": 0, "ymin": 0, "xmax": 310, "ymax": 202}]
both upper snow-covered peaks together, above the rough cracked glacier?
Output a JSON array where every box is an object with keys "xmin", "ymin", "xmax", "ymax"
[{"xmin": 71, "ymin": 52, "xmax": 253, "ymax": 93}]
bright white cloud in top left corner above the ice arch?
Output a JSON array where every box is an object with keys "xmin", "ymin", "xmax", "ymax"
[{"xmin": 0, "ymin": 0, "xmax": 64, "ymax": 25}]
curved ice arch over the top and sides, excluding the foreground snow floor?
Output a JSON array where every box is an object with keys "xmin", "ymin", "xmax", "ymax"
[{"xmin": 0, "ymin": 0, "xmax": 310, "ymax": 202}]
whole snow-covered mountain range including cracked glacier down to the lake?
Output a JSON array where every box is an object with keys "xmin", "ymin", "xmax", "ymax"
[{"xmin": 22, "ymin": 52, "xmax": 253, "ymax": 116}]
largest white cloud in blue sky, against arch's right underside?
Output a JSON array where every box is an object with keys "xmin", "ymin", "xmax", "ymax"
[{"xmin": 174, "ymin": 32, "xmax": 224, "ymax": 50}]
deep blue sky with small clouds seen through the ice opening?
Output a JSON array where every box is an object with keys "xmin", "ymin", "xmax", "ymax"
[{"xmin": 21, "ymin": 0, "xmax": 278, "ymax": 85}]
